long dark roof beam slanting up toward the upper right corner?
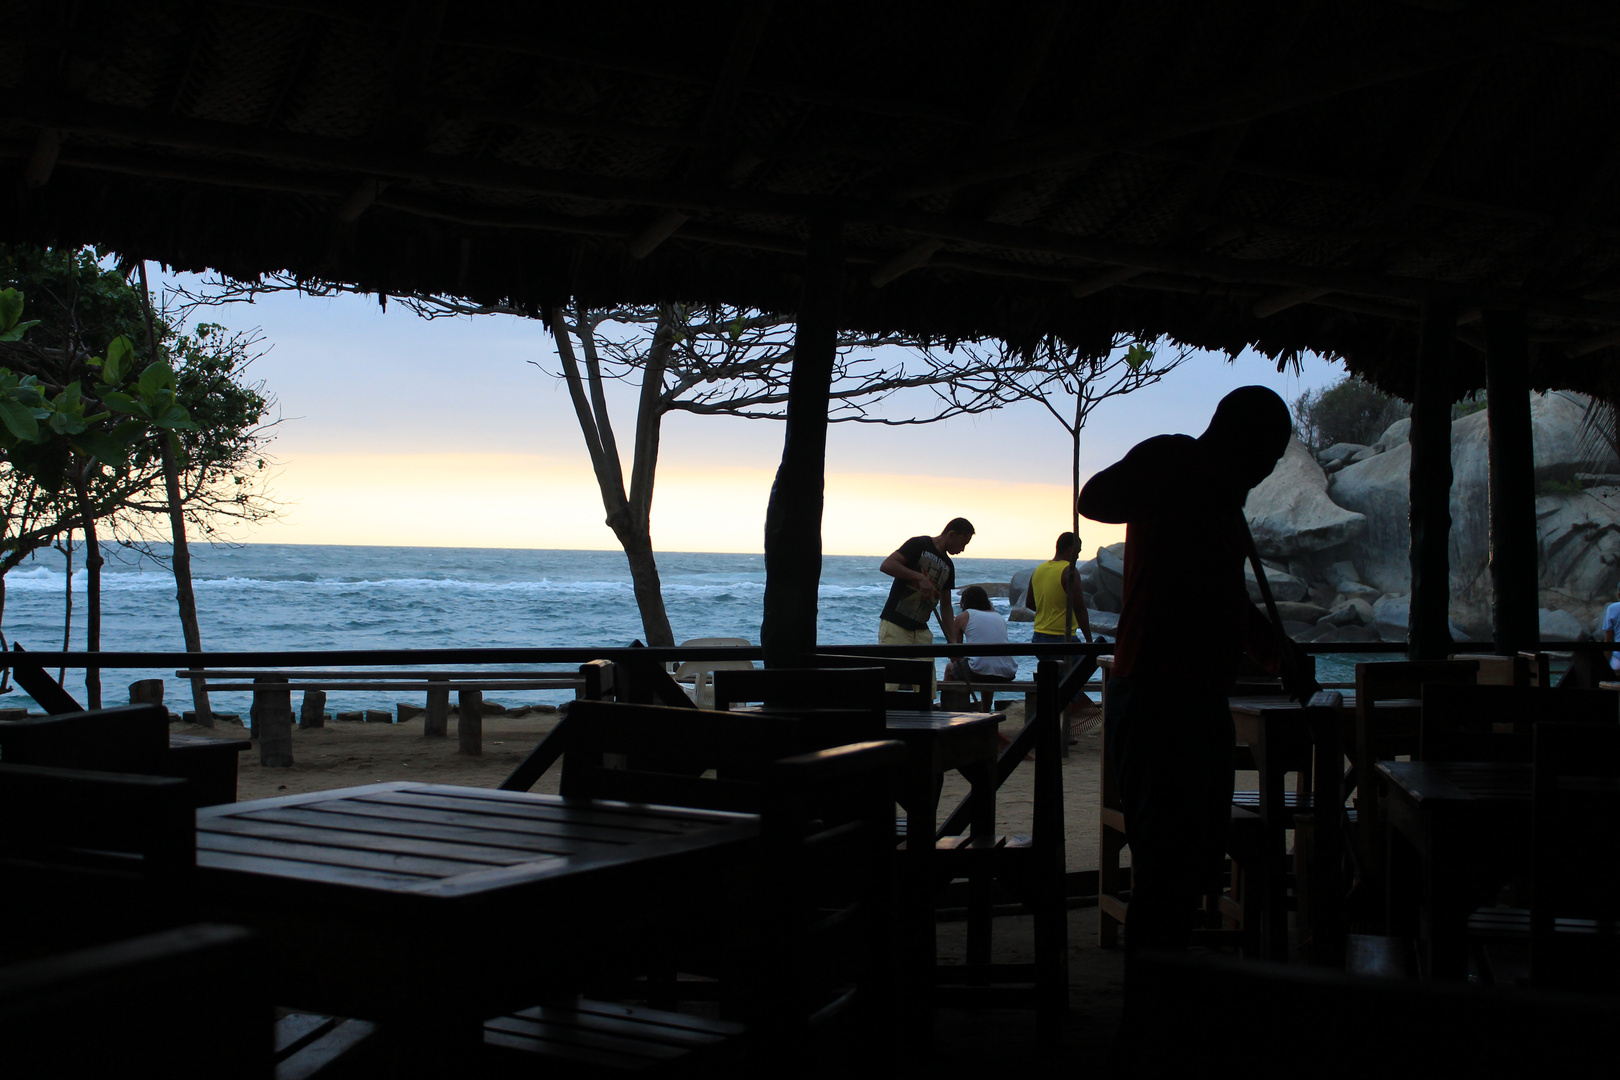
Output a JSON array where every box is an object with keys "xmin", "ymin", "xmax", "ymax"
[{"xmin": 873, "ymin": 18, "xmax": 1541, "ymax": 199}]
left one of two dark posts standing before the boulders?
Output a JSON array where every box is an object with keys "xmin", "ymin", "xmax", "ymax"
[{"xmin": 1406, "ymin": 300, "xmax": 1456, "ymax": 661}]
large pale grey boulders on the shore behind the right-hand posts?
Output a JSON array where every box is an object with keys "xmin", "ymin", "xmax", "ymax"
[{"xmin": 1013, "ymin": 393, "xmax": 1620, "ymax": 643}]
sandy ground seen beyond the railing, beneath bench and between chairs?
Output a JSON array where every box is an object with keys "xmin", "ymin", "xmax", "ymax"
[{"xmin": 170, "ymin": 703, "xmax": 1102, "ymax": 870}]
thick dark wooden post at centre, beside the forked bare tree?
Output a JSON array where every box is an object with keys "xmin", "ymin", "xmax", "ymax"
[{"xmin": 760, "ymin": 220, "xmax": 844, "ymax": 667}]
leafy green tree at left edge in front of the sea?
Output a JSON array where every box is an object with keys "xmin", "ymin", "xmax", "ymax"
[{"xmin": 0, "ymin": 248, "xmax": 274, "ymax": 722}]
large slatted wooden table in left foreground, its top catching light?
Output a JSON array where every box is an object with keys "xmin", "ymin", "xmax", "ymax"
[{"xmin": 198, "ymin": 782, "xmax": 760, "ymax": 1038}]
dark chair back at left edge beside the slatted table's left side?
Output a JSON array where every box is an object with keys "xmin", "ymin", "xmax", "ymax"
[{"xmin": 0, "ymin": 764, "xmax": 196, "ymax": 960}]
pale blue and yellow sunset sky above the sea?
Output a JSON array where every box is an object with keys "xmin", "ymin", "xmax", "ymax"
[{"xmin": 154, "ymin": 279, "xmax": 1343, "ymax": 559}]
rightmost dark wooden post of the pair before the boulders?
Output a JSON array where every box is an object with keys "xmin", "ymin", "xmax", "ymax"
[{"xmin": 1484, "ymin": 309, "xmax": 1541, "ymax": 656}]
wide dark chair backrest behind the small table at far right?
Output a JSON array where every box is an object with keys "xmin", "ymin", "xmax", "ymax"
[{"xmin": 1418, "ymin": 683, "xmax": 1620, "ymax": 763}]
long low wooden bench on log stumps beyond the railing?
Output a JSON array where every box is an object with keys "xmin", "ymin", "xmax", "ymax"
[{"xmin": 175, "ymin": 669, "xmax": 586, "ymax": 766}]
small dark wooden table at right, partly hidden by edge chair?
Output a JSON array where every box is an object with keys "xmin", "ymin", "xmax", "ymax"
[{"xmin": 1377, "ymin": 761, "xmax": 1533, "ymax": 980}]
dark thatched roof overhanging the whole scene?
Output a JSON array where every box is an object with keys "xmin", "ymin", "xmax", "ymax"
[{"xmin": 0, "ymin": 0, "xmax": 1620, "ymax": 390}]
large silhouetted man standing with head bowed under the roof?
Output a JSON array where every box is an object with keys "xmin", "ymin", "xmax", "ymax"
[{"xmin": 1079, "ymin": 387, "xmax": 1298, "ymax": 954}]
